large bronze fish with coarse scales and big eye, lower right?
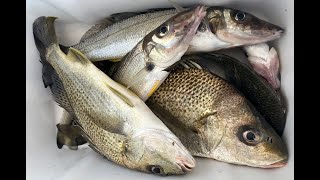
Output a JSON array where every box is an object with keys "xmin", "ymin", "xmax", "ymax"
[{"xmin": 146, "ymin": 65, "xmax": 288, "ymax": 168}]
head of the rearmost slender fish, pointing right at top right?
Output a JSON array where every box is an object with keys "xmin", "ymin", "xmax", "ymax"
[{"xmin": 206, "ymin": 7, "xmax": 284, "ymax": 47}]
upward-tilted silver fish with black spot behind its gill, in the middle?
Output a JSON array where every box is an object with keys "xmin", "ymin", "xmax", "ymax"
[{"xmin": 108, "ymin": 6, "xmax": 206, "ymax": 101}]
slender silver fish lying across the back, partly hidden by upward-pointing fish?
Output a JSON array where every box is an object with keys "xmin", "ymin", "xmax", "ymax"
[{"xmin": 72, "ymin": 6, "xmax": 284, "ymax": 62}]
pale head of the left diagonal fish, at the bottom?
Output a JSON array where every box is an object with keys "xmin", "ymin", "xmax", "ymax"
[{"xmin": 125, "ymin": 129, "xmax": 195, "ymax": 176}]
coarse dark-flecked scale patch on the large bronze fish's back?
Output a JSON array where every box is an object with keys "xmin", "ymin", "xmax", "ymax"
[{"xmin": 148, "ymin": 68, "xmax": 234, "ymax": 127}]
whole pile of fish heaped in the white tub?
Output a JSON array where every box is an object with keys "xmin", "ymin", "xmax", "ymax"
[{"xmin": 33, "ymin": 2, "xmax": 288, "ymax": 175}]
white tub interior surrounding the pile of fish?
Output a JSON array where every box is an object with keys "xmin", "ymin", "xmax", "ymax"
[{"xmin": 26, "ymin": 0, "xmax": 294, "ymax": 180}]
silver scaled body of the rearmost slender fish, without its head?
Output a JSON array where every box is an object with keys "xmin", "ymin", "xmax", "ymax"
[{"xmin": 73, "ymin": 10, "xmax": 176, "ymax": 61}]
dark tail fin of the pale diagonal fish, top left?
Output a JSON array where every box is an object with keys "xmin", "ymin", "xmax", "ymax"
[{"xmin": 33, "ymin": 16, "xmax": 57, "ymax": 56}]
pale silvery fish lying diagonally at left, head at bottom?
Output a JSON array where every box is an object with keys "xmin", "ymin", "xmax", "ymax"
[{"xmin": 33, "ymin": 16, "xmax": 195, "ymax": 175}]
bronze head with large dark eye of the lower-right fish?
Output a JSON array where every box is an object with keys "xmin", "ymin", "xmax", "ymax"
[{"xmin": 210, "ymin": 96, "xmax": 288, "ymax": 168}]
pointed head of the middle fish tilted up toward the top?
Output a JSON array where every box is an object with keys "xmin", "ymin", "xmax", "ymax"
[{"xmin": 143, "ymin": 6, "xmax": 206, "ymax": 69}]
